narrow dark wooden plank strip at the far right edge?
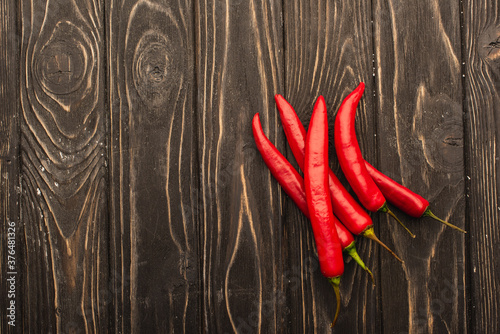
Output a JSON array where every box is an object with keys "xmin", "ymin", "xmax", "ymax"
[{"xmin": 462, "ymin": 0, "xmax": 500, "ymax": 333}]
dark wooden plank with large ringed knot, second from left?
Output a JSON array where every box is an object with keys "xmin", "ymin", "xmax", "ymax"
[{"xmin": 20, "ymin": 0, "xmax": 111, "ymax": 333}]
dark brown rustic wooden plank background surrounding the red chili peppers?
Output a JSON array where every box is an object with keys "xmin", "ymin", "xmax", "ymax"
[{"xmin": 0, "ymin": 0, "xmax": 500, "ymax": 334}]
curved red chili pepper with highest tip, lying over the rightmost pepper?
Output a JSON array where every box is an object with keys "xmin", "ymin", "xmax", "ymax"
[{"xmin": 334, "ymin": 83, "xmax": 415, "ymax": 238}]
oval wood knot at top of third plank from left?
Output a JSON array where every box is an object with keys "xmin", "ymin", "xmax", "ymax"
[{"xmin": 124, "ymin": 1, "xmax": 187, "ymax": 115}]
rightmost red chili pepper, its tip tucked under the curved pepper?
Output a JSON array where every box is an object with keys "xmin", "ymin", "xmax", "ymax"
[{"xmin": 365, "ymin": 161, "xmax": 467, "ymax": 233}]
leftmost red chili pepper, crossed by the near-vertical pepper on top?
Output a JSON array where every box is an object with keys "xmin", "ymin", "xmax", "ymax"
[{"xmin": 252, "ymin": 113, "xmax": 374, "ymax": 282}]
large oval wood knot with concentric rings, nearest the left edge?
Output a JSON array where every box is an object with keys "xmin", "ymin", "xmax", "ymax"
[{"xmin": 29, "ymin": 21, "xmax": 102, "ymax": 143}]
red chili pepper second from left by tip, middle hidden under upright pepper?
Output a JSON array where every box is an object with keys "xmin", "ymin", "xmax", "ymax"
[{"xmin": 274, "ymin": 94, "xmax": 403, "ymax": 262}]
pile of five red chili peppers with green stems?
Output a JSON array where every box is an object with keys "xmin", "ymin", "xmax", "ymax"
[{"xmin": 252, "ymin": 83, "xmax": 465, "ymax": 327}]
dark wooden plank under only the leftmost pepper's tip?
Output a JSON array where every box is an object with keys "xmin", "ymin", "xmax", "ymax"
[{"xmin": 195, "ymin": 0, "xmax": 286, "ymax": 333}]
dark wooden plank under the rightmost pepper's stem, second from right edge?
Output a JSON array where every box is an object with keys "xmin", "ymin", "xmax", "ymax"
[{"xmin": 374, "ymin": 0, "xmax": 468, "ymax": 333}]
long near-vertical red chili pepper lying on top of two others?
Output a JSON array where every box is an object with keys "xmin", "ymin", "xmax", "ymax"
[{"xmin": 304, "ymin": 96, "xmax": 344, "ymax": 327}]
